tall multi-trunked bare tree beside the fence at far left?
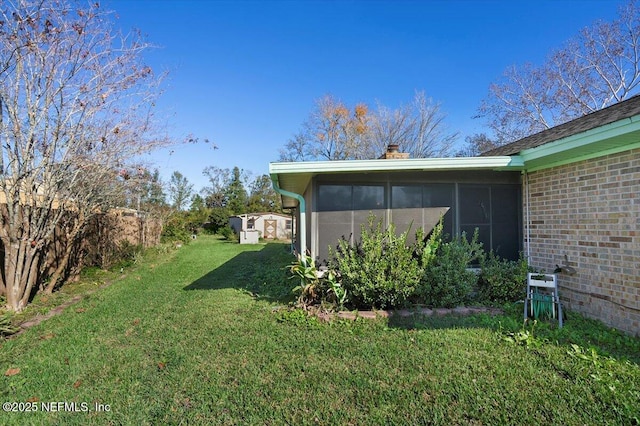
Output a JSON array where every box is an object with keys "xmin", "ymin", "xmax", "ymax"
[{"xmin": 0, "ymin": 0, "xmax": 167, "ymax": 311}]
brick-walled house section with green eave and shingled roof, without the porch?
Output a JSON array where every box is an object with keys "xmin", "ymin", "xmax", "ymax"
[{"xmin": 484, "ymin": 96, "xmax": 640, "ymax": 336}]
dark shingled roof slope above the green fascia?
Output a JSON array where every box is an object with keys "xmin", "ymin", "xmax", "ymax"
[{"xmin": 480, "ymin": 95, "xmax": 640, "ymax": 157}]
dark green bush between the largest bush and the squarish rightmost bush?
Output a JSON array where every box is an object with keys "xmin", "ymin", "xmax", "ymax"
[{"xmin": 416, "ymin": 230, "xmax": 484, "ymax": 308}]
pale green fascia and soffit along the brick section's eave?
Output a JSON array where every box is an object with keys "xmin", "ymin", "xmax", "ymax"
[{"xmin": 516, "ymin": 116, "xmax": 640, "ymax": 172}]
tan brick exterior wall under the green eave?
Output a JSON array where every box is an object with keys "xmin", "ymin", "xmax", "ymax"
[{"xmin": 524, "ymin": 149, "xmax": 640, "ymax": 336}]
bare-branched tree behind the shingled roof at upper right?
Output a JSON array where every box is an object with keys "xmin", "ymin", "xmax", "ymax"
[{"xmin": 479, "ymin": 1, "xmax": 640, "ymax": 143}]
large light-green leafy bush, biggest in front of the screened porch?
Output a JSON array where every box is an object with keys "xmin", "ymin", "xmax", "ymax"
[{"xmin": 330, "ymin": 215, "xmax": 442, "ymax": 309}]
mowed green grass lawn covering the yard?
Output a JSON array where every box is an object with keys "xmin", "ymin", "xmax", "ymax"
[{"xmin": 0, "ymin": 237, "xmax": 640, "ymax": 425}]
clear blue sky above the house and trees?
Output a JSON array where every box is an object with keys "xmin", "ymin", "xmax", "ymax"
[{"xmin": 102, "ymin": 0, "xmax": 622, "ymax": 190}]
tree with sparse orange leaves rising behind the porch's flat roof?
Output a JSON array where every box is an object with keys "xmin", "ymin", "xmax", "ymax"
[{"xmin": 280, "ymin": 92, "xmax": 457, "ymax": 161}]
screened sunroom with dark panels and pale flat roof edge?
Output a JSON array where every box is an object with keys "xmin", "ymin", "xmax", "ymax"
[{"xmin": 269, "ymin": 156, "xmax": 523, "ymax": 262}]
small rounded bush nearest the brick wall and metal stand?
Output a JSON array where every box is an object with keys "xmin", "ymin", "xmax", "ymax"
[{"xmin": 478, "ymin": 252, "xmax": 528, "ymax": 303}]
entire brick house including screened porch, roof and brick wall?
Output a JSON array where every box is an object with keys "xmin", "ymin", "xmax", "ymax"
[{"xmin": 269, "ymin": 96, "xmax": 640, "ymax": 335}]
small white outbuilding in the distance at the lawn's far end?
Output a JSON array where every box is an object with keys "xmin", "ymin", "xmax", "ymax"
[{"xmin": 229, "ymin": 213, "xmax": 293, "ymax": 244}]
